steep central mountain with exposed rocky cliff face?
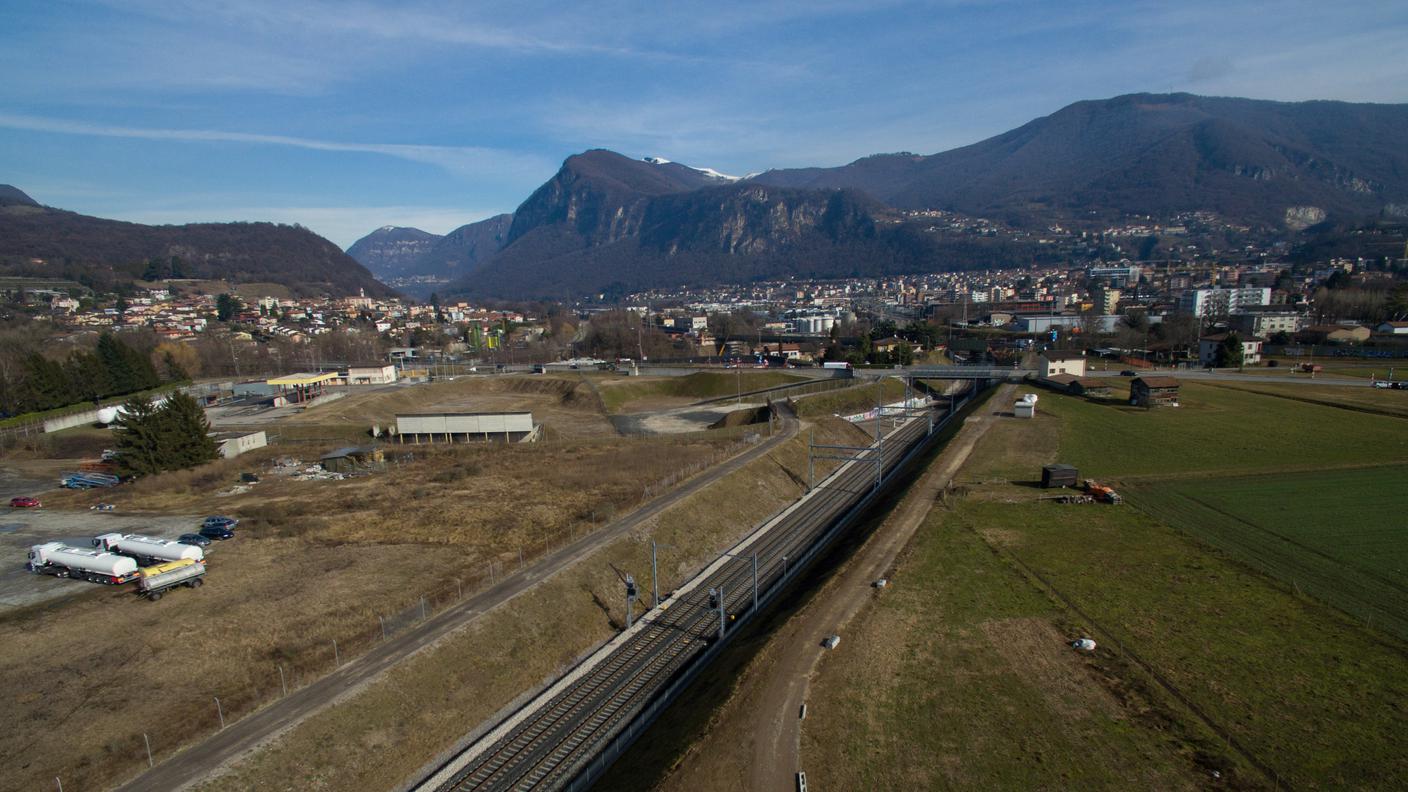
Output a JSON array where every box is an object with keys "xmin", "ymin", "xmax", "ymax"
[{"xmin": 446, "ymin": 152, "xmax": 914, "ymax": 297}]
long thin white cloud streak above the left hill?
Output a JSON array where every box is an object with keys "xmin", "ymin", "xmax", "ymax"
[{"xmin": 0, "ymin": 113, "xmax": 553, "ymax": 178}]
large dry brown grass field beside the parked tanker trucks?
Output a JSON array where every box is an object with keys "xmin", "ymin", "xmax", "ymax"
[{"xmin": 0, "ymin": 422, "xmax": 777, "ymax": 789}]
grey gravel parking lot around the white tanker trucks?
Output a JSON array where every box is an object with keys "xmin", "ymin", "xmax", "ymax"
[{"xmin": 0, "ymin": 506, "xmax": 213, "ymax": 613}]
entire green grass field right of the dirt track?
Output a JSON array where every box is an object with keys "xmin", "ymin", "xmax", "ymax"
[{"xmin": 804, "ymin": 385, "xmax": 1408, "ymax": 789}]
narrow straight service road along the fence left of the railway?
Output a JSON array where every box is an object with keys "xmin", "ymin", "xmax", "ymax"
[{"xmin": 118, "ymin": 406, "xmax": 797, "ymax": 792}]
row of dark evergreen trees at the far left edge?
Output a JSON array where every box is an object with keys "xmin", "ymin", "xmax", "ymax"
[{"xmin": 0, "ymin": 333, "xmax": 187, "ymax": 416}]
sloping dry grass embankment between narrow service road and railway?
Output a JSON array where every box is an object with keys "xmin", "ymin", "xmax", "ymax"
[{"xmin": 185, "ymin": 421, "xmax": 859, "ymax": 791}]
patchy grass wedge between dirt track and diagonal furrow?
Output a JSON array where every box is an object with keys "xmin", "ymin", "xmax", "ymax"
[{"xmin": 803, "ymin": 501, "xmax": 1210, "ymax": 789}]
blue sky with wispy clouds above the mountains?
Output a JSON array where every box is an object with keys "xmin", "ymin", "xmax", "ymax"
[{"xmin": 0, "ymin": 0, "xmax": 1408, "ymax": 247}]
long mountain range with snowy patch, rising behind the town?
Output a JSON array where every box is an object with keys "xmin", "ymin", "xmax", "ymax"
[{"xmin": 353, "ymin": 94, "xmax": 1408, "ymax": 297}]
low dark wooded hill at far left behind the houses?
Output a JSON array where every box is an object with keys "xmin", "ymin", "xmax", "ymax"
[{"xmin": 0, "ymin": 185, "xmax": 393, "ymax": 296}]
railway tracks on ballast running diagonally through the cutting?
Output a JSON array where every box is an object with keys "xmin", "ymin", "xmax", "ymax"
[{"xmin": 414, "ymin": 403, "xmax": 951, "ymax": 792}]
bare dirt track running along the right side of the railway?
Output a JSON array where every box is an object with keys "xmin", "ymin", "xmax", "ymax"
[{"xmin": 659, "ymin": 385, "xmax": 1015, "ymax": 792}]
